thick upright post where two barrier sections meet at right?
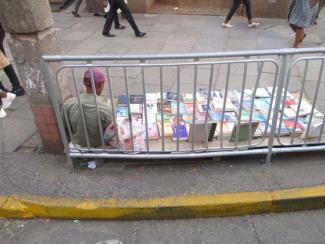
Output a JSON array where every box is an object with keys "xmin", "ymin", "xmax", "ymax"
[{"xmin": 265, "ymin": 54, "xmax": 288, "ymax": 164}]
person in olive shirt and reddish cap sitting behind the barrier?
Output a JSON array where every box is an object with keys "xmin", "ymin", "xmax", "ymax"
[{"xmin": 64, "ymin": 68, "xmax": 116, "ymax": 147}]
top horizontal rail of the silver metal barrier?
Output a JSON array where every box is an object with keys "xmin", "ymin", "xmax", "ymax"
[{"xmin": 43, "ymin": 47, "xmax": 325, "ymax": 62}]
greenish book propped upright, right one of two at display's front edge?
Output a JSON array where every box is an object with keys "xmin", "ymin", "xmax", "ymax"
[{"xmin": 229, "ymin": 121, "xmax": 259, "ymax": 142}]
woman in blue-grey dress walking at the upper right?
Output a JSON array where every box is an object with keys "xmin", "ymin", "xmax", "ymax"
[{"xmin": 288, "ymin": 0, "xmax": 319, "ymax": 48}]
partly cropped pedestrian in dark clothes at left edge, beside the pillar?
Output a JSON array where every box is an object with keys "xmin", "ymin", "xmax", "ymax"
[{"xmin": 0, "ymin": 23, "xmax": 25, "ymax": 96}]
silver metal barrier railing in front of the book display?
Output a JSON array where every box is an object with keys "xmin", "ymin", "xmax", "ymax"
[{"xmin": 43, "ymin": 48, "xmax": 325, "ymax": 162}]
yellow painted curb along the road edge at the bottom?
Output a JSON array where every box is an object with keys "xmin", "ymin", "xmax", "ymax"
[{"xmin": 0, "ymin": 186, "xmax": 325, "ymax": 220}]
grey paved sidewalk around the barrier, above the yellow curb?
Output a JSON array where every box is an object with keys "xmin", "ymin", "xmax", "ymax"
[{"xmin": 0, "ymin": 8, "xmax": 325, "ymax": 197}]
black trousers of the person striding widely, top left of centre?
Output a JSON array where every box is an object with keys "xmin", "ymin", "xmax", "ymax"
[{"xmin": 103, "ymin": 0, "xmax": 140, "ymax": 34}]
